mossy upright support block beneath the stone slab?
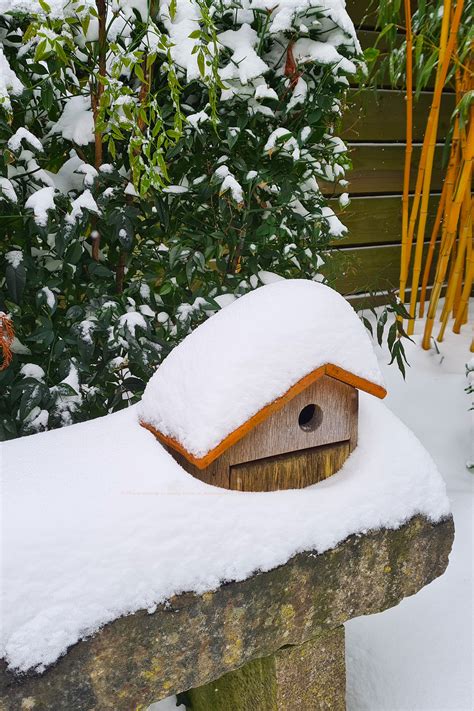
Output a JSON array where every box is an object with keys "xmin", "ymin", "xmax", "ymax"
[{"xmin": 188, "ymin": 626, "xmax": 346, "ymax": 711}]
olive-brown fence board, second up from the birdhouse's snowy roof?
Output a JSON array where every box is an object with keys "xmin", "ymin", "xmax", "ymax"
[{"xmin": 330, "ymin": 195, "xmax": 439, "ymax": 247}]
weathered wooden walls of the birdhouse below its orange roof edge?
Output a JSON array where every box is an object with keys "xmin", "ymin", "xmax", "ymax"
[{"xmin": 170, "ymin": 375, "xmax": 358, "ymax": 491}]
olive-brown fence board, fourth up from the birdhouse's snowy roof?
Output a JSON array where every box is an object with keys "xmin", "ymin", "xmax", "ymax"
[{"xmin": 342, "ymin": 89, "xmax": 455, "ymax": 143}]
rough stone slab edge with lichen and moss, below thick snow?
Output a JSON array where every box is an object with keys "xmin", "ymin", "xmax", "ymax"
[{"xmin": 0, "ymin": 516, "xmax": 454, "ymax": 711}]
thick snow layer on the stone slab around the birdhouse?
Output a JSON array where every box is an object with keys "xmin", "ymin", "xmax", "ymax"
[{"xmin": 0, "ymin": 393, "xmax": 449, "ymax": 670}]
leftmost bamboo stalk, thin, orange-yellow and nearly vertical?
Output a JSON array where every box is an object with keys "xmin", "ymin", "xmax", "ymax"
[{"xmin": 399, "ymin": 0, "xmax": 413, "ymax": 312}]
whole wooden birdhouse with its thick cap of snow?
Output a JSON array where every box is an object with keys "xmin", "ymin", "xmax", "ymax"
[{"xmin": 140, "ymin": 280, "xmax": 386, "ymax": 491}]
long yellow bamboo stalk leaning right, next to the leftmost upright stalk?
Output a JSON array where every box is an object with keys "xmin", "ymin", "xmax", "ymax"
[{"xmin": 407, "ymin": 0, "xmax": 464, "ymax": 335}]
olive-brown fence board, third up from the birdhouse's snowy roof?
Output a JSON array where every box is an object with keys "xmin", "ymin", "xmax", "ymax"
[{"xmin": 320, "ymin": 143, "xmax": 443, "ymax": 195}]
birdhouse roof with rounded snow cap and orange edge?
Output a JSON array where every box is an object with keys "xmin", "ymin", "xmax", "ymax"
[{"xmin": 140, "ymin": 279, "xmax": 386, "ymax": 467}]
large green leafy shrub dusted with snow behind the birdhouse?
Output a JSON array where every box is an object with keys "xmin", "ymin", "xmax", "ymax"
[{"xmin": 0, "ymin": 0, "xmax": 358, "ymax": 438}]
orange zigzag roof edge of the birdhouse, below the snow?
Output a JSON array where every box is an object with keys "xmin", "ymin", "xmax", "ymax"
[{"xmin": 140, "ymin": 363, "xmax": 387, "ymax": 469}]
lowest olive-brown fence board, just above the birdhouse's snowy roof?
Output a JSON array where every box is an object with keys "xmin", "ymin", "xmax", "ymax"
[{"xmin": 323, "ymin": 244, "xmax": 433, "ymax": 295}]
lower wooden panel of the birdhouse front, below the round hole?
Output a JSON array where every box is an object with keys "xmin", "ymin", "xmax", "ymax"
[{"xmin": 230, "ymin": 441, "xmax": 351, "ymax": 491}]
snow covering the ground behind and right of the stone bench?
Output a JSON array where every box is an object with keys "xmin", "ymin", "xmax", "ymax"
[{"xmin": 346, "ymin": 307, "xmax": 474, "ymax": 711}]
